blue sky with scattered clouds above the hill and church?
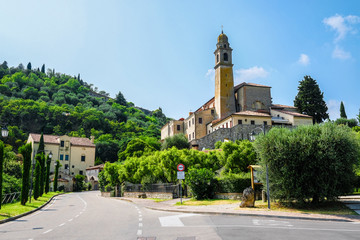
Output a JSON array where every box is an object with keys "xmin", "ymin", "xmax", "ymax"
[{"xmin": 0, "ymin": 0, "xmax": 360, "ymax": 120}]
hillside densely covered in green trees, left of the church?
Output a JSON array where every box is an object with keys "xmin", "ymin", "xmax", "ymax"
[{"xmin": 0, "ymin": 61, "xmax": 167, "ymax": 163}]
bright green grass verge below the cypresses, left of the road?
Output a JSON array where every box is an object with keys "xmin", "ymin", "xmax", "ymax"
[{"xmin": 0, "ymin": 192, "xmax": 60, "ymax": 220}]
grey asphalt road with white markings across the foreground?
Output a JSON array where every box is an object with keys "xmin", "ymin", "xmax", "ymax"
[{"xmin": 0, "ymin": 192, "xmax": 360, "ymax": 240}]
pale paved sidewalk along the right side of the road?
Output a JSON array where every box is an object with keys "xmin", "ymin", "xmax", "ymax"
[{"xmin": 116, "ymin": 196, "xmax": 360, "ymax": 222}]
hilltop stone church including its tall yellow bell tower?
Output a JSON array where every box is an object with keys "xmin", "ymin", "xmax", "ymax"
[{"xmin": 161, "ymin": 32, "xmax": 312, "ymax": 148}]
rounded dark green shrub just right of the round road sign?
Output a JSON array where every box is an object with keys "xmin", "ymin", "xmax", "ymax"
[{"xmin": 185, "ymin": 168, "xmax": 215, "ymax": 200}]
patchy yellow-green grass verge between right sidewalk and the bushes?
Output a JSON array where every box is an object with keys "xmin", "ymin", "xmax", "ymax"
[{"xmin": 175, "ymin": 199, "xmax": 358, "ymax": 215}]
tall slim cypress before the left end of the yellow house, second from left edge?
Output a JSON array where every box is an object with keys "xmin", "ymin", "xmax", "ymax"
[{"xmin": 19, "ymin": 143, "xmax": 32, "ymax": 205}]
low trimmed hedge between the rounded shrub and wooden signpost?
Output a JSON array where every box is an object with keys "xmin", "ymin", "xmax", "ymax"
[{"xmin": 215, "ymin": 173, "xmax": 251, "ymax": 193}]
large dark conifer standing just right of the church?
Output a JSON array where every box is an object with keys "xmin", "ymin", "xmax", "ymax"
[{"xmin": 294, "ymin": 76, "xmax": 329, "ymax": 124}]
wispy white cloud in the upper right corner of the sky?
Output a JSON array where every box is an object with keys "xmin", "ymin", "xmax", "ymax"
[{"xmin": 323, "ymin": 14, "xmax": 360, "ymax": 42}]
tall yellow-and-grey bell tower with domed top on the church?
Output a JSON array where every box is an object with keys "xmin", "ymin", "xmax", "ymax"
[{"xmin": 214, "ymin": 31, "xmax": 235, "ymax": 119}]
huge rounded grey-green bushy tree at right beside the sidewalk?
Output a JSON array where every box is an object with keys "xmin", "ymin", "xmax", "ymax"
[{"xmin": 254, "ymin": 123, "xmax": 359, "ymax": 204}]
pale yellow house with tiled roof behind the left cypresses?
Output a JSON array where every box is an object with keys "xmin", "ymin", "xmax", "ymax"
[{"xmin": 27, "ymin": 133, "xmax": 95, "ymax": 177}]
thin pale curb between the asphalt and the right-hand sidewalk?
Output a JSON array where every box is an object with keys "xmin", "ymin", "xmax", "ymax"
[{"xmin": 119, "ymin": 199, "xmax": 360, "ymax": 222}]
